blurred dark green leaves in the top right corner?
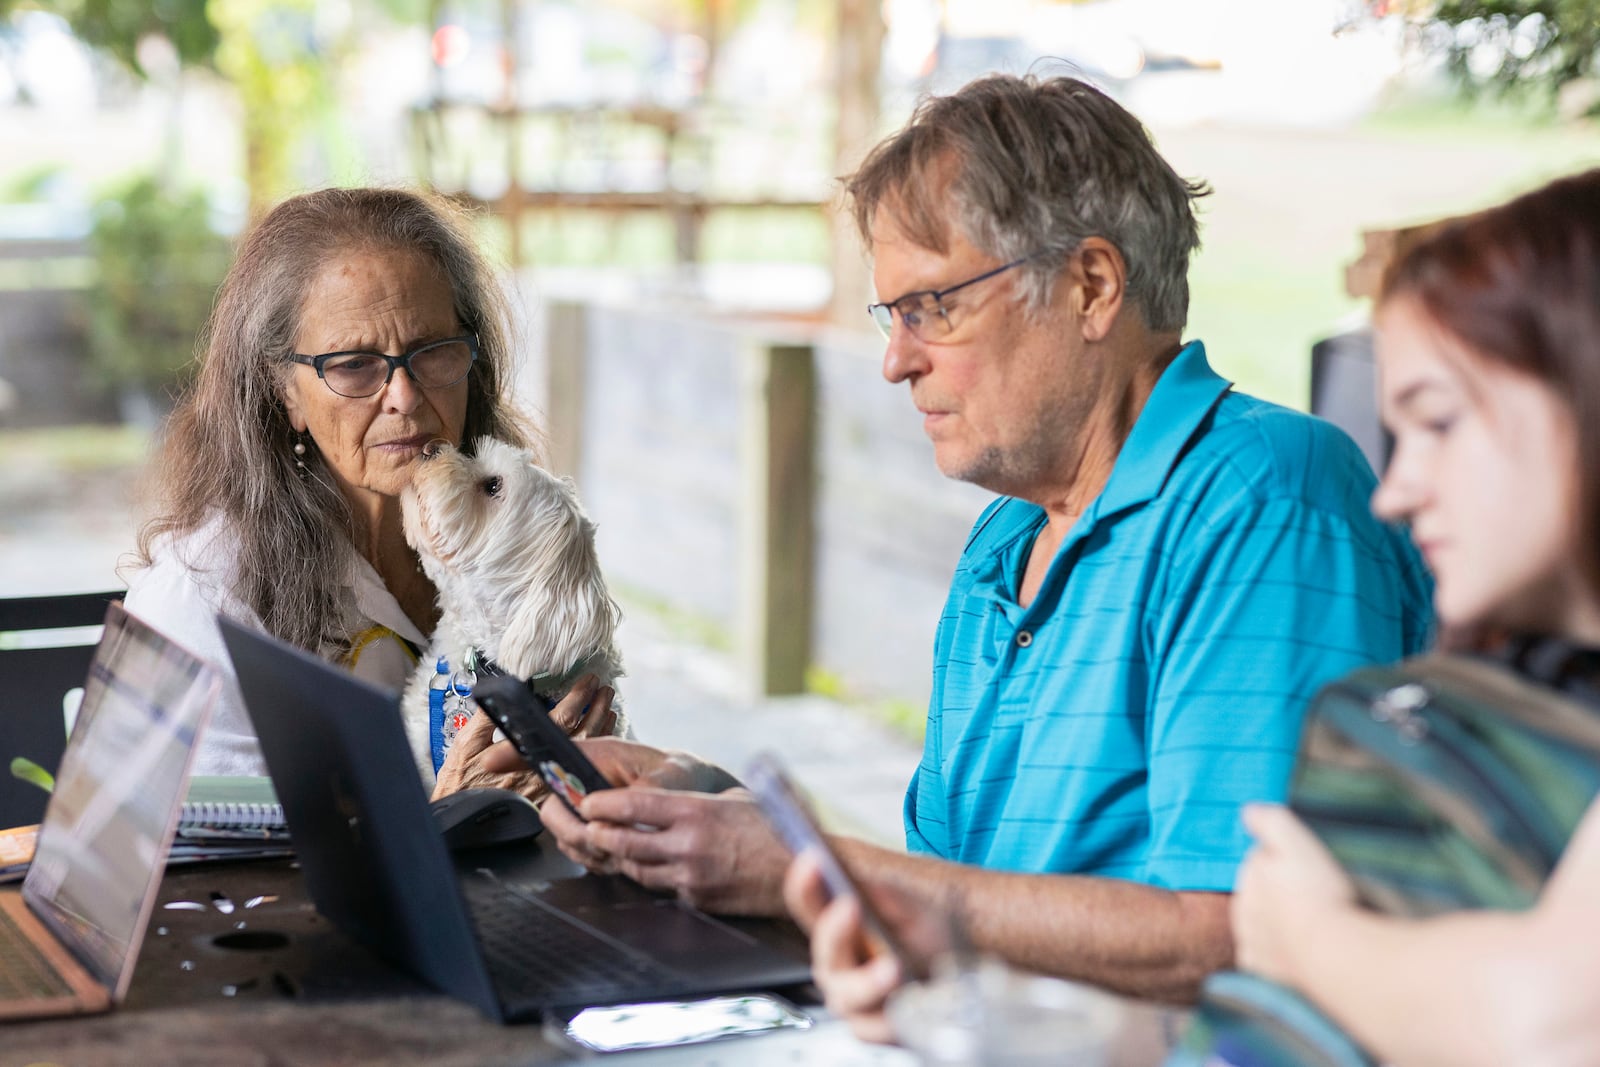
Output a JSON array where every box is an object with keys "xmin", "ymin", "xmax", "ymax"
[{"xmin": 1429, "ymin": 0, "xmax": 1600, "ymax": 103}]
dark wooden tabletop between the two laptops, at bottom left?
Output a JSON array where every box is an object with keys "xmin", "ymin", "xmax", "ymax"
[{"xmin": 9, "ymin": 849, "xmax": 825, "ymax": 1067}]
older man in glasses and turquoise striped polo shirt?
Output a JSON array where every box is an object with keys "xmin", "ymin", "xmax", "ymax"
[{"xmin": 521, "ymin": 77, "xmax": 1429, "ymax": 1037}]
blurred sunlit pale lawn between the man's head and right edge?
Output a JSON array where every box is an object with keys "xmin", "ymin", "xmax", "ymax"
[{"xmin": 1155, "ymin": 101, "xmax": 1600, "ymax": 406}]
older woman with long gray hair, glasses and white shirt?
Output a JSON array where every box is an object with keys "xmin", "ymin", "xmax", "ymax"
[{"xmin": 128, "ymin": 189, "xmax": 611, "ymax": 784}]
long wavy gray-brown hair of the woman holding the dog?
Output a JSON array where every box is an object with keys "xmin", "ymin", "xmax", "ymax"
[{"xmin": 134, "ymin": 189, "xmax": 534, "ymax": 651}]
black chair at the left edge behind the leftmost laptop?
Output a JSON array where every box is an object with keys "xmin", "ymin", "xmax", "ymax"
[{"xmin": 0, "ymin": 590, "xmax": 122, "ymax": 827}]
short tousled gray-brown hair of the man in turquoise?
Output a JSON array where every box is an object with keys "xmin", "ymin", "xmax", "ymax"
[{"xmin": 845, "ymin": 75, "xmax": 1210, "ymax": 333}]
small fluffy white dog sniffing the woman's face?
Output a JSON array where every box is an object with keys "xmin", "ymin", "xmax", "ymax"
[{"xmin": 400, "ymin": 437, "xmax": 626, "ymax": 781}]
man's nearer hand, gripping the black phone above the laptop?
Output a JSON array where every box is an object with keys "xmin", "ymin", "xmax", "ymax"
[{"xmin": 544, "ymin": 783, "xmax": 789, "ymax": 915}]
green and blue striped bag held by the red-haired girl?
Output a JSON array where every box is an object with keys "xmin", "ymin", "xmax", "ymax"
[{"xmin": 1168, "ymin": 654, "xmax": 1600, "ymax": 1067}]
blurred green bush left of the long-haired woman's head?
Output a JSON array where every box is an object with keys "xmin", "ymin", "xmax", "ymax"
[{"xmin": 88, "ymin": 178, "xmax": 230, "ymax": 390}]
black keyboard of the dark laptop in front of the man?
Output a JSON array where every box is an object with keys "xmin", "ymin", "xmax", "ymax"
[{"xmin": 461, "ymin": 878, "xmax": 678, "ymax": 1014}]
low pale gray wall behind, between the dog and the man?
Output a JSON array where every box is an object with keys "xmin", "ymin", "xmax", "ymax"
[{"xmin": 525, "ymin": 304, "xmax": 990, "ymax": 704}]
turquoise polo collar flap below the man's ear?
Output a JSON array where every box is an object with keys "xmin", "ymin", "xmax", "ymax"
[{"xmin": 1080, "ymin": 341, "xmax": 1234, "ymax": 526}]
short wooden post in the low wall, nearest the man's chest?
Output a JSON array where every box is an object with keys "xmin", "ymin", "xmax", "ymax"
[{"xmin": 738, "ymin": 337, "xmax": 816, "ymax": 696}]
